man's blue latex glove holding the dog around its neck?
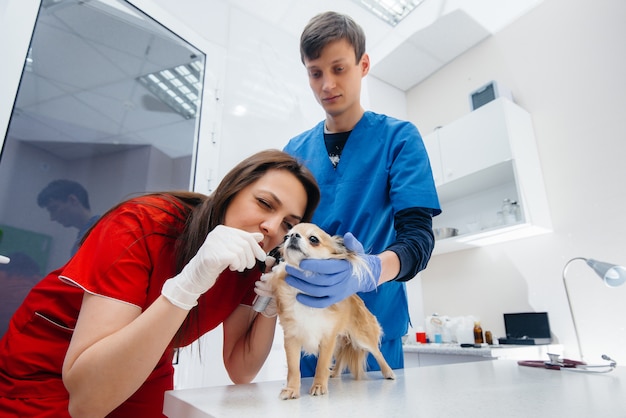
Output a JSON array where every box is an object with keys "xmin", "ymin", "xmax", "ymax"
[{"xmin": 285, "ymin": 232, "xmax": 381, "ymax": 308}]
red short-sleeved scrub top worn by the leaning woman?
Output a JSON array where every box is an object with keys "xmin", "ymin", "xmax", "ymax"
[{"xmin": 0, "ymin": 196, "xmax": 260, "ymax": 418}]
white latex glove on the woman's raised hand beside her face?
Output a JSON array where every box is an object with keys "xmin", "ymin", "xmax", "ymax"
[{"xmin": 161, "ymin": 225, "xmax": 266, "ymax": 310}]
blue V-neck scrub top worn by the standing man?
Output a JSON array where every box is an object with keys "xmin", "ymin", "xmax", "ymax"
[{"xmin": 284, "ymin": 111, "xmax": 441, "ymax": 346}]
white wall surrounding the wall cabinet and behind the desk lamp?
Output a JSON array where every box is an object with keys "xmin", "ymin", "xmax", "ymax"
[{"xmin": 407, "ymin": 0, "xmax": 626, "ymax": 363}]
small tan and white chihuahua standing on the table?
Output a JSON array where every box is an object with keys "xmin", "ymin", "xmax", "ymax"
[{"xmin": 267, "ymin": 223, "xmax": 395, "ymax": 399}]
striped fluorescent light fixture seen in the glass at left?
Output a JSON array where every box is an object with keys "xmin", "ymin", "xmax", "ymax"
[{"xmin": 137, "ymin": 61, "xmax": 202, "ymax": 119}]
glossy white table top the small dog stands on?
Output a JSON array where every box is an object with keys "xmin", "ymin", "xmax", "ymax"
[{"xmin": 164, "ymin": 360, "xmax": 626, "ymax": 418}]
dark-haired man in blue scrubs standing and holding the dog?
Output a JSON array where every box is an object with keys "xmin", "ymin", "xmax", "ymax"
[{"xmin": 285, "ymin": 12, "xmax": 441, "ymax": 377}]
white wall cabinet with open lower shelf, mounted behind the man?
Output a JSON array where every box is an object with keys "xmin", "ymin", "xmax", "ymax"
[{"xmin": 424, "ymin": 98, "xmax": 552, "ymax": 255}]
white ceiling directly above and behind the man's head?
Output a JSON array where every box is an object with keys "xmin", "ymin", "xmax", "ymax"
[{"xmin": 227, "ymin": 0, "xmax": 543, "ymax": 91}]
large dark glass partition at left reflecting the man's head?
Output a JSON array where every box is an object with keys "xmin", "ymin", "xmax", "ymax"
[{"xmin": 0, "ymin": 0, "xmax": 206, "ymax": 335}]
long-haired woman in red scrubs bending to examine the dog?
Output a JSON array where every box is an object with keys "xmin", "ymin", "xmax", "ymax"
[{"xmin": 0, "ymin": 150, "xmax": 319, "ymax": 418}]
